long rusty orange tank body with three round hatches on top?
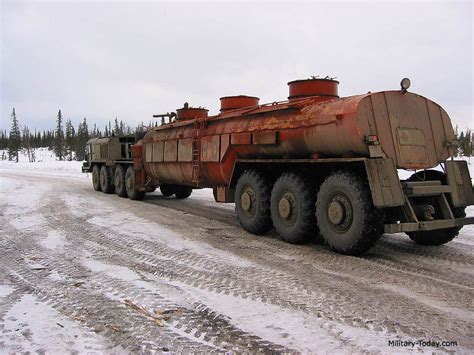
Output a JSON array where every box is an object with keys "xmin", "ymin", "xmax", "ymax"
[{"xmin": 143, "ymin": 79, "xmax": 454, "ymax": 187}]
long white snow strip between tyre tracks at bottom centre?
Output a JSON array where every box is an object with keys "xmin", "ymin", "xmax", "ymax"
[{"xmin": 164, "ymin": 280, "xmax": 396, "ymax": 353}]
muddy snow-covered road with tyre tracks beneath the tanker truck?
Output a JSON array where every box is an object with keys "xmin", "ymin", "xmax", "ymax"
[{"xmin": 0, "ymin": 162, "xmax": 474, "ymax": 353}]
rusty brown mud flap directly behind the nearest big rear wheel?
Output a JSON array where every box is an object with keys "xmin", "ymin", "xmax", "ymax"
[{"xmin": 365, "ymin": 158, "xmax": 405, "ymax": 208}]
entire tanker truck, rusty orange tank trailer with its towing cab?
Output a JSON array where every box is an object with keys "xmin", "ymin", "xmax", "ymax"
[{"xmin": 85, "ymin": 78, "xmax": 474, "ymax": 255}]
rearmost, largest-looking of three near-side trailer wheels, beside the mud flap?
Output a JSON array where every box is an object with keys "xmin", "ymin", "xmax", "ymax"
[{"xmin": 316, "ymin": 172, "xmax": 384, "ymax": 255}]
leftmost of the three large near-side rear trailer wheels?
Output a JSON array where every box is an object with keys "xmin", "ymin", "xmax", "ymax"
[{"xmin": 235, "ymin": 170, "xmax": 272, "ymax": 234}]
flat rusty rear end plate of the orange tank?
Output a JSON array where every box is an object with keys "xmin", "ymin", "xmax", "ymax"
[{"xmin": 357, "ymin": 91, "xmax": 454, "ymax": 169}]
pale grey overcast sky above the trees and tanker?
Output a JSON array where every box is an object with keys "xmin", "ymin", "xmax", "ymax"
[{"xmin": 0, "ymin": 0, "xmax": 474, "ymax": 129}]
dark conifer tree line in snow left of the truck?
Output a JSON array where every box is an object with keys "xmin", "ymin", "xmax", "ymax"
[{"xmin": 0, "ymin": 108, "xmax": 149, "ymax": 162}]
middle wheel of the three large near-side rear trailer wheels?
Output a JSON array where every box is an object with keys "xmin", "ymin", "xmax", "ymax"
[{"xmin": 270, "ymin": 173, "xmax": 318, "ymax": 244}]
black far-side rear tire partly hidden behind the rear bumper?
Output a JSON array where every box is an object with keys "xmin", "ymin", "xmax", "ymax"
[{"xmin": 407, "ymin": 170, "xmax": 466, "ymax": 245}]
